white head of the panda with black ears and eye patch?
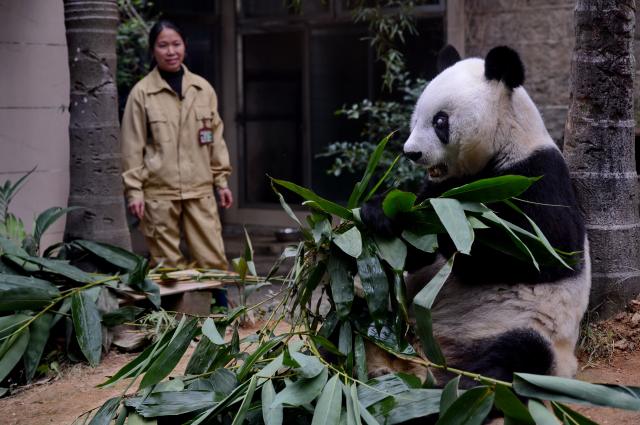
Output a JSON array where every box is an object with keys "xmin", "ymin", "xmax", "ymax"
[{"xmin": 404, "ymin": 46, "xmax": 554, "ymax": 181}]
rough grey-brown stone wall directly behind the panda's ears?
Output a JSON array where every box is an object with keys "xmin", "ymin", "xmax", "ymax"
[{"xmin": 457, "ymin": 0, "xmax": 575, "ymax": 141}]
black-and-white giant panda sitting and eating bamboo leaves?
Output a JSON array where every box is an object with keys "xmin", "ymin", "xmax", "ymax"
[{"xmin": 361, "ymin": 46, "xmax": 591, "ymax": 381}]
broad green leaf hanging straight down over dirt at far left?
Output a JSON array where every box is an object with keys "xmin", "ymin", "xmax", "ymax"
[{"xmin": 71, "ymin": 291, "xmax": 102, "ymax": 367}]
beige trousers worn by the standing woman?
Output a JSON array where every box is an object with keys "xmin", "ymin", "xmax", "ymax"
[{"xmin": 141, "ymin": 195, "xmax": 229, "ymax": 270}]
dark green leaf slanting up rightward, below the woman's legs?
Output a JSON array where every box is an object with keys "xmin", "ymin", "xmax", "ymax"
[{"xmin": 140, "ymin": 318, "xmax": 198, "ymax": 389}]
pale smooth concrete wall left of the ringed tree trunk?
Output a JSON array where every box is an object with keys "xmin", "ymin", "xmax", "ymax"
[{"xmin": 0, "ymin": 0, "xmax": 69, "ymax": 246}]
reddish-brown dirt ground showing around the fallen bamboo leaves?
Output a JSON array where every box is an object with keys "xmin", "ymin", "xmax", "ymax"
[{"xmin": 0, "ymin": 318, "xmax": 640, "ymax": 425}]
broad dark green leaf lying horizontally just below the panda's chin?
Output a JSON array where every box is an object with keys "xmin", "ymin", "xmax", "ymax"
[{"xmin": 442, "ymin": 175, "xmax": 540, "ymax": 204}]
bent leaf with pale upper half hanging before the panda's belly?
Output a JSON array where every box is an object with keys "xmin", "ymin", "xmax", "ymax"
[{"xmin": 413, "ymin": 254, "xmax": 455, "ymax": 365}]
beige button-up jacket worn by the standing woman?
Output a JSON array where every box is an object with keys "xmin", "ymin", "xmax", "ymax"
[{"xmin": 120, "ymin": 67, "xmax": 231, "ymax": 202}]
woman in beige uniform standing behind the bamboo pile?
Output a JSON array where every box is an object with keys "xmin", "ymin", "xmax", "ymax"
[{"xmin": 121, "ymin": 21, "xmax": 233, "ymax": 269}]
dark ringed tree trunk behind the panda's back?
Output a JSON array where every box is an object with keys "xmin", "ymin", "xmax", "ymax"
[{"xmin": 564, "ymin": 0, "xmax": 640, "ymax": 317}]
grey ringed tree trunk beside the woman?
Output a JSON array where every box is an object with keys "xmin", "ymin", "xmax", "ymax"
[{"xmin": 64, "ymin": 0, "xmax": 131, "ymax": 249}]
